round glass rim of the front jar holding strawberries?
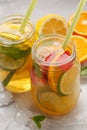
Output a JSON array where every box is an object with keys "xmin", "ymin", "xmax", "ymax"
[{"xmin": 32, "ymin": 34, "xmax": 76, "ymax": 67}]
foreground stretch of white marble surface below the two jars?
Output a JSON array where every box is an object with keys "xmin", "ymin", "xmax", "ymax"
[{"xmin": 0, "ymin": 78, "xmax": 87, "ymax": 130}]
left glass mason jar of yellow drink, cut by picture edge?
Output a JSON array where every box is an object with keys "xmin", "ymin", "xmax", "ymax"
[{"xmin": 0, "ymin": 15, "xmax": 36, "ymax": 93}]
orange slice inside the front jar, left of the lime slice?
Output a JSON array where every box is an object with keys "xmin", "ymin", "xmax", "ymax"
[{"xmin": 48, "ymin": 48, "xmax": 72, "ymax": 94}]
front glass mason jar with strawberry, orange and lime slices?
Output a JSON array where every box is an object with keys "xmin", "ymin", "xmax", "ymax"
[{"xmin": 30, "ymin": 35, "xmax": 80, "ymax": 115}]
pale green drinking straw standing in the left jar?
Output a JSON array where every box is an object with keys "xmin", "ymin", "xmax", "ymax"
[{"xmin": 19, "ymin": 0, "xmax": 37, "ymax": 33}]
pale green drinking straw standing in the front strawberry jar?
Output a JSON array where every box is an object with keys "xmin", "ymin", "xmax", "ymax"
[{"xmin": 62, "ymin": 0, "xmax": 86, "ymax": 49}]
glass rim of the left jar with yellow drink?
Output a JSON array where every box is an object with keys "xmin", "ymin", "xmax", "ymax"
[{"xmin": 0, "ymin": 14, "xmax": 35, "ymax": 46}]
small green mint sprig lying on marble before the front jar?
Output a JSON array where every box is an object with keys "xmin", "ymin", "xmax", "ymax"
[{"xmin": 32, "ymin": 115, "xmax": 45, "ymax": 129}]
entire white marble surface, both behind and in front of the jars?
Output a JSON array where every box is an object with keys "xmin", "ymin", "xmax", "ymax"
[{"xmin": 0, "ymin": 0, "xmax": 87, "ymax": 130}]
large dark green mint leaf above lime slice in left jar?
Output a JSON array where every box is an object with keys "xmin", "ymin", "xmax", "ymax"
[{"xmin": 0, "ymin": 47, "xmax": 31, "ymax": 59}]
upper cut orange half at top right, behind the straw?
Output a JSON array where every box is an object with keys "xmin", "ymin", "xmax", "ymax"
[{"xmin": 69, "ymin": 11, "xmax": 87, "ymax": 36}]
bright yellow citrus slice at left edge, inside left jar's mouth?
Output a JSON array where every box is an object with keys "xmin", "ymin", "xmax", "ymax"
[{"xmin": 0, "ymin": 32, "xmax": 20, "ymax": 40}]
